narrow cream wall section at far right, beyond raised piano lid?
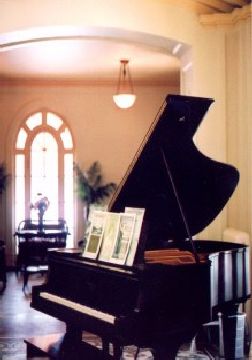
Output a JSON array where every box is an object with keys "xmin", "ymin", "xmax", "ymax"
[{"xmin": 226, "ymin": 12, "xmax": 252, "ymax": 234}]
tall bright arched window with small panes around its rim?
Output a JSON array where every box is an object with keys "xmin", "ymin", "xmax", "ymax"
[{"xmin": 15, "ymin": 111, "xmax": 73, "ymax": 246}]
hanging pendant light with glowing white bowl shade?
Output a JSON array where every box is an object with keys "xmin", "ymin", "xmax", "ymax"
[{"xmin": 113, "ymin": 59, "xmax": 136, "ymax": 109}]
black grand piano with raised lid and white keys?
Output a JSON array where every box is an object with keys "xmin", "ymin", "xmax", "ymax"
[{"xmin": 31, "ymin": 95, "xmax": 250, "ymax": 360}]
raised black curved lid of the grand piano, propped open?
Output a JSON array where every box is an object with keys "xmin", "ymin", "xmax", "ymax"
[{"xmin": 109, "ymin": 95, "xmax": 239, "ymax": 248}]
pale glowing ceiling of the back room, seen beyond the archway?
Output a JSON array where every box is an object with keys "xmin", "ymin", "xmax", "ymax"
[{"xmin": 0, "ymin": 38, "xmax": 180, "ymax": 82}]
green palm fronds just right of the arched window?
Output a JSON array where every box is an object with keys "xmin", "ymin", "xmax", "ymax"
[{"xmin": 74, "ymin": 161, "xmax": 116, "ymax": 206}]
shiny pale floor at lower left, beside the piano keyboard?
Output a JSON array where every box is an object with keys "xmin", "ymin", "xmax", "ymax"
[{"xmin": 0, "ymin": 273, "xmax": 65, "ymax": 360}]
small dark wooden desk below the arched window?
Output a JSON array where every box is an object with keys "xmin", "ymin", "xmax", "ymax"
[{"xmin": 14, "ymin": 219, "xmax": 68, "ymax": 290}]
